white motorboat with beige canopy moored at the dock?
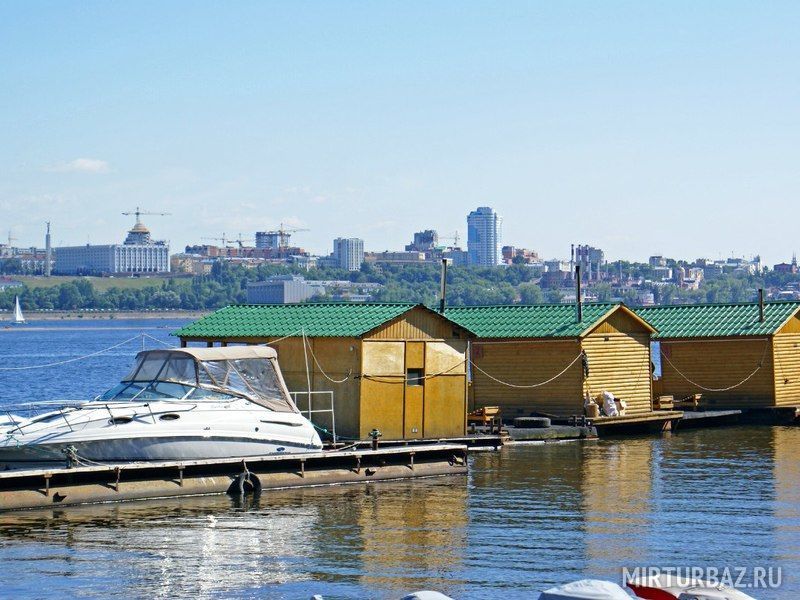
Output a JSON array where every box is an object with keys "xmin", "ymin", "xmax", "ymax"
[{"xmin": 0, "ymin": 346, "xmax": 322, "ymax": 464}]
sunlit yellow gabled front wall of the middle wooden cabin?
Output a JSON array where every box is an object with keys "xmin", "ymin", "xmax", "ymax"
[{"xmin": 582, "ymin": 324, "xmax": 653, "ymax": 415}]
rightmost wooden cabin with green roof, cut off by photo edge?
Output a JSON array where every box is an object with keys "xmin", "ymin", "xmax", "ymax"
[{"xmin": 636, "ymin": 302, "xmax": 800, "ymax": 409}]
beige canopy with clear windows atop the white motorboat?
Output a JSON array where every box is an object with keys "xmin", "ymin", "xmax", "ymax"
[{"xmin": 122, "ymin": 346, "xmax": 299, "ymax": 412}]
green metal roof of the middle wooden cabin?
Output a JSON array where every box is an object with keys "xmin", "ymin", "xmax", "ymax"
[{"xmin": 445, "ymin": 303, "xmax": 620, "ymax": 338}]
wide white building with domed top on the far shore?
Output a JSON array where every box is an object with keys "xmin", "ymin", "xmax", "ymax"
[{"xmin": 54, "ymin": 216, "xmax": 170, "ymax": 275}]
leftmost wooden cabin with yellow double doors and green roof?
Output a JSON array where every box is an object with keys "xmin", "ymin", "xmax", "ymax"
[{"xmin": 174, "ymin": 303, "xmax": 473, "ymax": 439}]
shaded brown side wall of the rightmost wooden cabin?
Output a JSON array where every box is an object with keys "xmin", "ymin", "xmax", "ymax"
[{"xmin": 660, "ymin": 338, "xmax": 775, "ymax": 409}]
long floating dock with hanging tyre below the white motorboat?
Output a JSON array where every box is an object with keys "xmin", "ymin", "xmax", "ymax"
[{"xmin": 0, "ymin": 444, "xmax": 467, "ymax": 511}]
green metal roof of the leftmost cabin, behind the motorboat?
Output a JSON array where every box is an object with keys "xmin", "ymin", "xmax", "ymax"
[{"xmin": 172, "ymin": 302, "xmax": 444, "ymax": 339}]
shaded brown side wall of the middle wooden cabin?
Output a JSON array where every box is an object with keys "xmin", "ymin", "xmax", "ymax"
[{"xmin": 472, "ymin": 340, "xmax": 583, "ymax": 419}]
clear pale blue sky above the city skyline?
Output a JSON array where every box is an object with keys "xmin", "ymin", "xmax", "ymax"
[{"xmin": 0, "ymin": 0, "xmax": 800, "ymax": 264}]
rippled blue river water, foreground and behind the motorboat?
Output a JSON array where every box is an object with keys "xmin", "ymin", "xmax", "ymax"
[{"xmin": 0, "ymin": 321, "xmax": 800, "ymax": 599}]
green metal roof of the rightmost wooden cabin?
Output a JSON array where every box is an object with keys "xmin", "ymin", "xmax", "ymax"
[{"xmin": 634, "ymin": 302, "xmax": 800, "ymax": 339}]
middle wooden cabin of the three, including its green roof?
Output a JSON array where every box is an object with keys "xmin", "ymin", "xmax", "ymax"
[{"xmin": 445, "ymin": 304, "xmax": 654, "ymax": 419}]
